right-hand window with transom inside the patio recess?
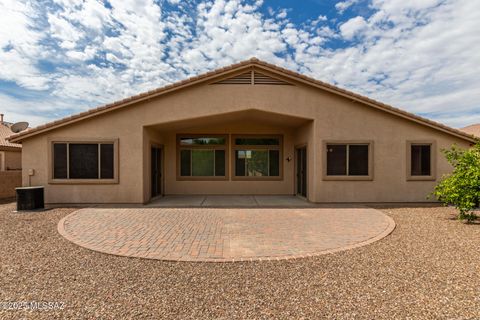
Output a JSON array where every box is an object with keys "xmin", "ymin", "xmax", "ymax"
[{"xmin": 233, "ymin": 136, "xmax": 282, "ymax": 179}]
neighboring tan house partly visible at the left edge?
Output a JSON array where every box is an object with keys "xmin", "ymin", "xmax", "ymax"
[{"xmin": 0, "ymin": 114, "xmax": 22, "ymax": 199}]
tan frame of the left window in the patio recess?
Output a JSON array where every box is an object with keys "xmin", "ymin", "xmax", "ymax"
[{"xmin": 175, "ymin": 133, "xmax": 230, "ymax": 181}]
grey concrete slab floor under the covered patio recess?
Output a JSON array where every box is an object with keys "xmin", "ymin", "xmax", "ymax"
[{"xmin": 146, "ymin": 195, "xmax": 315, "ymax": 208}]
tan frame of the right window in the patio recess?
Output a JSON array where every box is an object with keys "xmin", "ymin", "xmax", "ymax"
[{"xmin": 230, "ymin": 134, "xmax": 284, "ymax": 181}]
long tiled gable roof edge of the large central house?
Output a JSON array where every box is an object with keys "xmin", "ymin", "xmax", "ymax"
[{"xmin": 5, "ymin": 58, "xmax": 475, "ymax": 142}]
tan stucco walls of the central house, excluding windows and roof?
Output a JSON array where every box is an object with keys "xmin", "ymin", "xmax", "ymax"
[{"xmin": 10, "ymin": 60, "xmax": 473, "ymax": 203}]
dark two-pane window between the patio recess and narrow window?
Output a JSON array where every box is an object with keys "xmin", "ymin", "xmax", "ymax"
[{"xmin": 324, "ymin": 142, "xmax": 373, "ymax": 180}]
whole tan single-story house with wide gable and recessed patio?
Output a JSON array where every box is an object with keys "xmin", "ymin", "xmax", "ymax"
[{"xmin": 10, "ymin": 58, "xmax": 475, "ymax": 204}]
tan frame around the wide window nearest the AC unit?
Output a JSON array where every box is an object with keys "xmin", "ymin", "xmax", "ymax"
[{"xmin": 48, "ymin": 138, "xmax": 119, "ymax": 184}]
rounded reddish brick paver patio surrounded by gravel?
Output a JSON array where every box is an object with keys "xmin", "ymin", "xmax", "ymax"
[{"xmin": 58, "ymin": 208, "xmax": 395, "ymax": 262}]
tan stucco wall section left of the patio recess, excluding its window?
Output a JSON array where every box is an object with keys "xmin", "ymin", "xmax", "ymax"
[{"xmin": 22, "ymin": 106, "xmax": 143, "ymax": 203}]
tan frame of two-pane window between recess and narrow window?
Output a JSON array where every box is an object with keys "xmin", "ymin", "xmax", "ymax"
[{"xmin": 322, "ymin": 140, "xmax": 374, "ymax": 181}]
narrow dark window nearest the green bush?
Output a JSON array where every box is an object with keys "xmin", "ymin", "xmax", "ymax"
[{"xmin": 407, "ymin": 141, "xmax": 435, "ymax": 180}]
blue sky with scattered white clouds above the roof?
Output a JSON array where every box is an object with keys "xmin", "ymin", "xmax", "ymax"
[{"xmin": 0, "ymin": 0, "xmax": 480, "ymax": 127}]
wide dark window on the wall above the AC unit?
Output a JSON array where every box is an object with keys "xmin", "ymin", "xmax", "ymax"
[{"xmin": 51, "ymin": 141, "xmax": 117, "ymax": 182}]
